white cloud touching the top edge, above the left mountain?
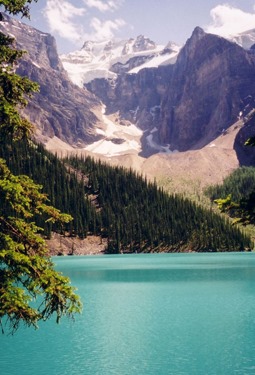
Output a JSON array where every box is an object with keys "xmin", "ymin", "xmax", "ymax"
[{"xmin": 43, "ymin": 0, "xmax": 86, "ymax": 42}]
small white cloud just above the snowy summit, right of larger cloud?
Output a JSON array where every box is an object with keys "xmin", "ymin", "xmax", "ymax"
[{"xmin": 90, "ymin": 17, "xmax": 126, "ymax": 40}]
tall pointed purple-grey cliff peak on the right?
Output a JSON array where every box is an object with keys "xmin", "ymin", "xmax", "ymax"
[{"xmin": 159, "ymin": 28, "xmax": 255, "ymax": 151}]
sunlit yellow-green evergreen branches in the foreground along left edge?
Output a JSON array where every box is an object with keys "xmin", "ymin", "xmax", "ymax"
[{"xmin": 0, "ymin": 0, "xmax": 81, "ymax": 332}]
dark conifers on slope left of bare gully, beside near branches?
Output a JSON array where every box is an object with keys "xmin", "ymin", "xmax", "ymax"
[{"xmin": 0, "ymin": 139, "xmax": 98, "ymax": 238}]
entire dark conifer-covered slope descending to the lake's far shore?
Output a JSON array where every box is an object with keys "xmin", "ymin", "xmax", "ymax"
[{"xmin": 0, "ymin": 142, "xmax": 251, "ymax": 253}]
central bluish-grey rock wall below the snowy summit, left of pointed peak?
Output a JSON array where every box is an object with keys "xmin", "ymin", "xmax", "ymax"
[{"xmin": 86, "ymin": 65, "xmax": 172, "ymax": 130}]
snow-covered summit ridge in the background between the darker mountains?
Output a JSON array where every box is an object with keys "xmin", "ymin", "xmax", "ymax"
[{"xmin": 60, "ymin": 35, "xmax": 180, "ymax": 87}]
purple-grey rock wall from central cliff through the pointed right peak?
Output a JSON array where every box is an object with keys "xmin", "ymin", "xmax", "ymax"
[{"xmin": 86, "ymin": 28, "xmax": 255, "ymax": 151}]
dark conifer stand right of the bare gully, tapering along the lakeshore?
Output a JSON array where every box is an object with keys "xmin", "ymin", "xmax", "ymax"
[{"xmin": 65, "ymin": 157, "xmax": 250, "ymax": 253}]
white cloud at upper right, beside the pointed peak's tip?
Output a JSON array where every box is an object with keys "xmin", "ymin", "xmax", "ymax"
[{"xmin": 205, "ymin": 4, "xmax": 255, "ymax": 37}]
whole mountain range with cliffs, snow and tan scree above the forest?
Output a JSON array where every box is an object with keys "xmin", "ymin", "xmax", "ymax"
[{"xmin": 0, "ymin": 15, "xmax": 255, "ymax": 206}]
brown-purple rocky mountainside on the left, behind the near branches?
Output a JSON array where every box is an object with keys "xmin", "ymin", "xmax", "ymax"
[{"xmin": 0, "ymin": 14, "xmax": 101, "ymax": 147}]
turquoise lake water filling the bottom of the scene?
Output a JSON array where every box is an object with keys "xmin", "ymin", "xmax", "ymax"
[{"xmin": 0, "ymin": 253, "xmax": 255, "ymax": 375}]
